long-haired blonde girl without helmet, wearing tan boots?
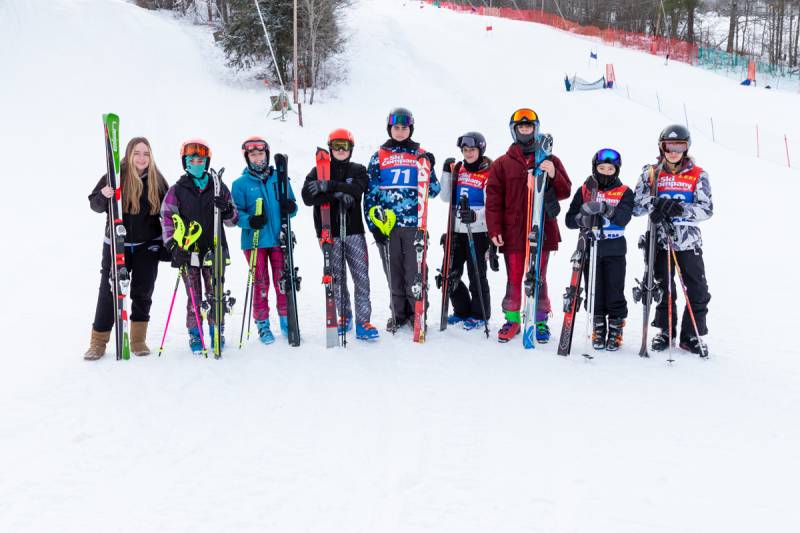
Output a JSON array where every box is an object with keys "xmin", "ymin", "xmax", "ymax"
[{"xmin": 83, "ymin": 137, "xmax": 168, "ymax": 361}]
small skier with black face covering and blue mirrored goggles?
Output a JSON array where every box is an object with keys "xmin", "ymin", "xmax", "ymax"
[{"xmin": 565, "ymin": 148, "xmax": 634, "ymax": 351}]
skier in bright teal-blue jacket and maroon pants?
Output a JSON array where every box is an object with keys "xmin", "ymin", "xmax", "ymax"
[{"xmin": 231, "ymin": 137, "xmax": 297, "ymax": 344}]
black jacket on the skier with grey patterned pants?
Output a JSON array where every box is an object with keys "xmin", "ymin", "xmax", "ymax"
[{"xmin": 302, "ymin": 159, "xmax": 369, "ymax": 238}]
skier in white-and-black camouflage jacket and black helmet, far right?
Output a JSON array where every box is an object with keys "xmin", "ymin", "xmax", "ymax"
[{"xmin": 633, "ymin": 124, "xmax": 714, "ymax": 356}]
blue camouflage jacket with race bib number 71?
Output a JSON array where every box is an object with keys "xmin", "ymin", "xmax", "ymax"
[{"xmin": 364, "ymin": 141, "xmax": 441, "ymax": 231}]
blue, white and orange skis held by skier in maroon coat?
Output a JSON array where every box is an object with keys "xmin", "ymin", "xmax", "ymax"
[{"xmin": 522, "ymin": 134, "xmax": 553, "ymax": 349}]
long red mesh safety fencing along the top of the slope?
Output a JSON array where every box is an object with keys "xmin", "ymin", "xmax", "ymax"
[{"xmin": 424, "ymin": 0, "xmax": 697, "ymax": 64}]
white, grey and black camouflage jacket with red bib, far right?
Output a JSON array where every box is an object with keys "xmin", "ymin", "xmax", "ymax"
[{"xmin": 633, "ymin": 158, "xmax": 714, "ymax": 251}]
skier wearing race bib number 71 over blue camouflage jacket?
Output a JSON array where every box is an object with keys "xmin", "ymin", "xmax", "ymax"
[{"xmin": 364, "ymin": 107, "xmax": 441, "ymax": 331}]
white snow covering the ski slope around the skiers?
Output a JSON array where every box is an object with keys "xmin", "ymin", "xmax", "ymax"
[{"xmin": 0, "ymin": 0, "xmax": 800, "ymax": 533}]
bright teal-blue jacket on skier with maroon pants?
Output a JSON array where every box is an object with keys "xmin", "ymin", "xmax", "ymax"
[{"xmin": 231, "ymin": 168, "xmax": 297, "ymax": 250}]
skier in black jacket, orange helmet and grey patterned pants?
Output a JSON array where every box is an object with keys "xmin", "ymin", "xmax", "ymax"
[{"xmin": 302, "ymin": 129, "xmax": 378, "ymax": 340}]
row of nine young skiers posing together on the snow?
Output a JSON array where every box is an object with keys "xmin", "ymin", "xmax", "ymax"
[{"xmin": 84, "ymin": 108, "xmax": 713, "ymax": 360}]
